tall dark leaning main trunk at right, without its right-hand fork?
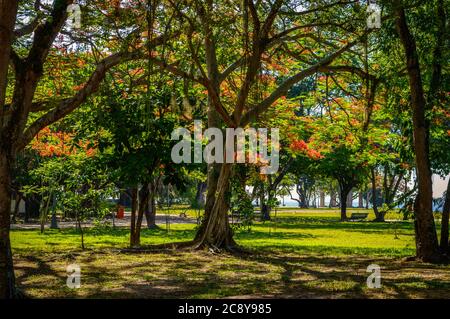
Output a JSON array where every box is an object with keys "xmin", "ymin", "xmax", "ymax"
[{"xmin": 395, "ymin": 1, "xmax": 440, "ymax": 262}]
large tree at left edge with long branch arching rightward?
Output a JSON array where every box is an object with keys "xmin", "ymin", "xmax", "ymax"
[{"xmin": 0, "ymin": 0, "xmax": 168, "ymax": 298}]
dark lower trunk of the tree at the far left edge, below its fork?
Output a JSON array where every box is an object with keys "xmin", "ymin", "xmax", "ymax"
[{"xmin": 0, "ymin": 154, "xmax": 16, "ymax": 299}]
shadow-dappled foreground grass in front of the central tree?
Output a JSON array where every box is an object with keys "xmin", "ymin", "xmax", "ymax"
[{"xmin": 17, "ymin": 250, "xmax": 450, "ymax": 298}]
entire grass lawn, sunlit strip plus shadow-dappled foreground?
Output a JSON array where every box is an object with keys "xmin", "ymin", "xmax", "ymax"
[{"xmin": 11, "ymin": 210, "xmax": 450, "ymax": 298}]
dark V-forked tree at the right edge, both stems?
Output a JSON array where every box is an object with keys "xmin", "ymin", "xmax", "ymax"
[{"xmin": 393, "ymin": 0, "xmax": 446, "ymax": 261}]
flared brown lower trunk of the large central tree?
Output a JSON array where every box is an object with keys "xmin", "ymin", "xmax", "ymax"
[{"xmin": 194, "ymin": 163, "xmax": 236, "ymax": 250}]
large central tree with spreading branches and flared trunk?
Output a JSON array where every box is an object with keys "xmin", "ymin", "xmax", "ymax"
[{"xmin": 154, "ymin": 0, "xmax": 365, "ymax": 250}]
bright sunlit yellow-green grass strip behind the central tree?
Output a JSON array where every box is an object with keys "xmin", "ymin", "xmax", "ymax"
[{"xmin": 11, "ymin": 213, "xmax": 414, "ymax": 256}]
